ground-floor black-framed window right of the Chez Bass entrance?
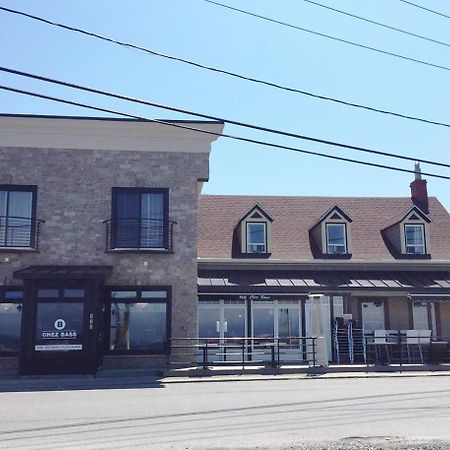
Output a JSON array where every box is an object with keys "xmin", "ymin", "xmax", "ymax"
[{"xmin": 109, "ymin": 288, "xmax": 170, "ymax": 353}]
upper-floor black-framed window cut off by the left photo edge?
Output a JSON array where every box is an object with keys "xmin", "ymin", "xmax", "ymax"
[{"xmin": 0, "ymin": 185, "xmax": 36, "ymax": 248}]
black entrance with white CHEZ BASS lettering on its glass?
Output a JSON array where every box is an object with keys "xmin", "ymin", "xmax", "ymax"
[{"xmin": 20, "ymin": 280, "xmax": 101, "ymax": 374}]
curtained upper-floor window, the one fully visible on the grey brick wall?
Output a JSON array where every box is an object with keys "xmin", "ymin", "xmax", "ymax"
[{"xmin": 112, "ymin": 188, "xmax": 168, "ymax": 249}]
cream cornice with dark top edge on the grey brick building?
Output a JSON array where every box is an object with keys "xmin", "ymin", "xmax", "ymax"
[{"xmin": 0, "ymin": 114, "xmax": 224, "ymax": 153}]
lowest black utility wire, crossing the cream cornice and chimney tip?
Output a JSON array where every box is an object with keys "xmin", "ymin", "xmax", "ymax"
[{"xmin": 0, "ymin": 85, "xmax": 450, "ymax": 180}]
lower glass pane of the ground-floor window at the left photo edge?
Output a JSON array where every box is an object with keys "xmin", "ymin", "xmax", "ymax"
[{"xmin": 0, "ymin": 303, "xmax": 22, "ymax": 352}]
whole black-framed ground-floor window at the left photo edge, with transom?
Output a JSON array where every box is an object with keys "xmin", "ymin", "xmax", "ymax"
[{"xmin": 0, "ymin": 288, "xmax": 23, "ymax": 355}]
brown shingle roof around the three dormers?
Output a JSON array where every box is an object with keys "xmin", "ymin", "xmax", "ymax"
[{"xmin": 198, "ymin": 195, "xmax": 450, "ymax": 261}]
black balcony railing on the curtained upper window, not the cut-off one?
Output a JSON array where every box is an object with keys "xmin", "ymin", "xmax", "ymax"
[{"xmin": 103, "ymin": 218, "xmax": 176, "ymax": 253}]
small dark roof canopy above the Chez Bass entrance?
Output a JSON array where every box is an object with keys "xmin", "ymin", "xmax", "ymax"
[{"xmin": 14, "ymin": 266, "xmax": 112, "ymax": 280}]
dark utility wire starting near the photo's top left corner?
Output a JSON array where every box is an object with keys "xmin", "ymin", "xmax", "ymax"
[{"xmin": 0, "ymin": 6, "xmax": 450, "ymax": 127}]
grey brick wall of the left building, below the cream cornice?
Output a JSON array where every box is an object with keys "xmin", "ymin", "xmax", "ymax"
[{"xmin": 0, "ymin": 148, "xmax": 208, "ymax": 337}]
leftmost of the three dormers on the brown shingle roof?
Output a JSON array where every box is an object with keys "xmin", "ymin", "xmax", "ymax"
[{"xmin": 237, "ymin": 204, "xmax": 273, "ymax": 257}]
